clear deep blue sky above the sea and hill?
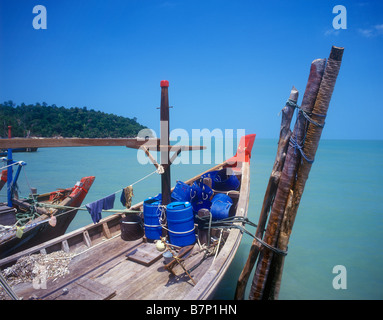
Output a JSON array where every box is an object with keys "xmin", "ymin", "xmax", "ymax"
[{"xmin": 0, "ymin": 0, "xmax": 383, "ymax": 139}]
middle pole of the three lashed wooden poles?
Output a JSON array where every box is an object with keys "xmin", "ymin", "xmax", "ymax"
[{"xmin": 249, "ymin": 59, "xmax": 325, "ymax": 300}]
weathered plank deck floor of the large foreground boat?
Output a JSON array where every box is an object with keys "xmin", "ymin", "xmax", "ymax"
[{"xmin": 10, "ymin": 232, "xmax": 219, "ymax": 300}]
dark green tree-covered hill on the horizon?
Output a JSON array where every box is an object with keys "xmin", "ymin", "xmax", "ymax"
[{"xmin": 0, "ymin": 101, "xmax": 146, "ymax": 138}]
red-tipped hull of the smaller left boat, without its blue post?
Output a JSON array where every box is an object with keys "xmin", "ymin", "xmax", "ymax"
[{"xmin": 0, "ymin": 174, "xmax": 95, "ymax": 258}]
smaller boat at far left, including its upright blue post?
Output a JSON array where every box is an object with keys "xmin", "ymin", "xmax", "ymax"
[{"xmin": 0, "ymin": 122, "xmax": 95, "ymax": 258}]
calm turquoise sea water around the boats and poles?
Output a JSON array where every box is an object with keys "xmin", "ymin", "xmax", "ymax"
[{"xmin": 0, "ymin": 138, "xmax": 383, "ymax": 300}]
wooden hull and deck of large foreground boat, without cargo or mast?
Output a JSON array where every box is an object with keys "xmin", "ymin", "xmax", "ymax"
[{"xmin": 0, "ymin": 135, "xmax": 255, "ymax": 300}]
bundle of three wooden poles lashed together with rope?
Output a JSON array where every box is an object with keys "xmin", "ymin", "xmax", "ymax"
[{"xmin": 235, "ymin": 46, "xmax": 344, "ymax": 300}]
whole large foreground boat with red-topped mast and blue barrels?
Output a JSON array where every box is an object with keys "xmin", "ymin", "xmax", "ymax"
[{"xmin": 0, "ymin": 80, "xmax": 255, "ymax": 300}]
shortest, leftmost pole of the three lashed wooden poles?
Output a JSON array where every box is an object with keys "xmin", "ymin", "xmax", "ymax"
[{"xmin": 235, "ymin": 87, "xmax": 299, "ymax": 300}]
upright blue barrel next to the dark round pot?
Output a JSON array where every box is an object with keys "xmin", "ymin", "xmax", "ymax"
[{"xmin": 144, "ymin": 197, "xmax": 162, "ymax": 240}]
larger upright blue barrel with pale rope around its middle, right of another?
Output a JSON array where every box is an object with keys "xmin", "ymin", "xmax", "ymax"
[{"xmin": 166, "ymin": 202, "xmax": 196, "ymax": 247}]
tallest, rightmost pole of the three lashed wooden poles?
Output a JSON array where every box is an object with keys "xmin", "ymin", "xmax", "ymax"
[{"xmin": 270, "ymin": 47, "xmax": 344, "ymax": 299}]
